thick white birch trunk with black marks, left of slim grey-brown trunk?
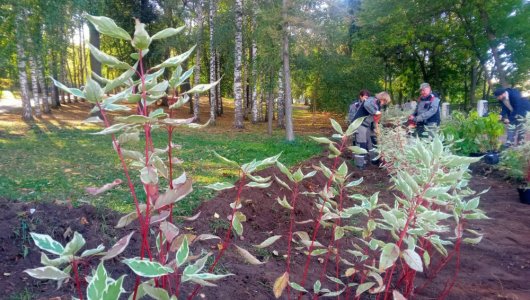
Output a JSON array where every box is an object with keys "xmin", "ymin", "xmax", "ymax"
[{"xmin": 234, "ymin": 0, "xmax": 243, "ymax": 128}]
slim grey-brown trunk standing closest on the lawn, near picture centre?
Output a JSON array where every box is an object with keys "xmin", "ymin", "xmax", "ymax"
[{"xmin": 282, "ymin": 0, "xmax": 294, "ymax": 142}]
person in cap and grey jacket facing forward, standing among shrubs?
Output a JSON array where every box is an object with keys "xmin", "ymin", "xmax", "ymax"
[{"xmin": 409, "ymin": 82, "xmax": 440, "ymax": 136}]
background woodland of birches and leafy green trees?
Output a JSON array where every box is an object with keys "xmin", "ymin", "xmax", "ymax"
[{"xmin": 0, "ymin": 0, "xmax": 530, "ymax": 126}]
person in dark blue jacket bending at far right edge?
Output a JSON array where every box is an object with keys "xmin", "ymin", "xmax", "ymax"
[{"xmin": 493, "ymin": 88, "xmax": 530, "ymax": 147}]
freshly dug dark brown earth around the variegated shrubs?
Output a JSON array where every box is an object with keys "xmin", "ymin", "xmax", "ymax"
[{"xmin": 0, "ymin": 158, "xmax": 530, "ymax": 299}]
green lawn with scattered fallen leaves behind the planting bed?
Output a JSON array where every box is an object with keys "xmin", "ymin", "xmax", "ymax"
[{"xmin": 0, "ymin": 124, "xmax": 321, "ymax": 215}]
